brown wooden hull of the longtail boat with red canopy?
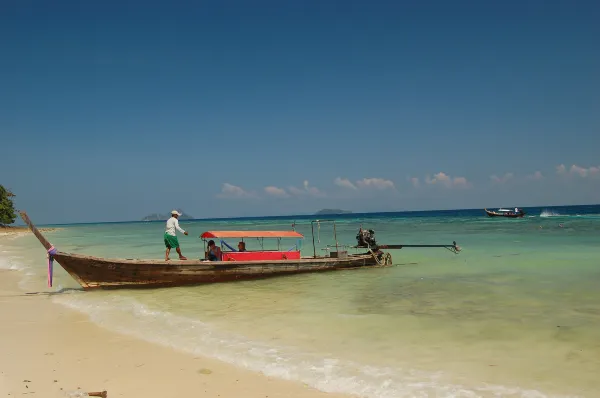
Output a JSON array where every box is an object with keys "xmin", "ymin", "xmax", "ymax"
[{"xmin": 54, "ymin": 252, "xmax": 391, "ymax": 290}]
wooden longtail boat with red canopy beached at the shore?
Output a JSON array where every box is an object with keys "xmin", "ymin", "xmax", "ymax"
[{"xmin": 20, "ymin": 211, "xmax": 460, "ymax": 290}]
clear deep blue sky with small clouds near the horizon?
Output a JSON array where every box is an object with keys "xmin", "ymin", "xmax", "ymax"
[{"xmin": 0, "ymin": 1, "xmax": 600, "ymax": 223}]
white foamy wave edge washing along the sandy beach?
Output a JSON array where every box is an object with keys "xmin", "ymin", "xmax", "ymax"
[{"xmin": 53, "ymin": 291, "xmax": 568, "ymax": 398}]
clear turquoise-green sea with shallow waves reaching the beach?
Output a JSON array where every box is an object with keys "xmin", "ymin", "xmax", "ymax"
[{"xmin": 0, "ymin": 205, "xmax": 600, "ymax": 398}]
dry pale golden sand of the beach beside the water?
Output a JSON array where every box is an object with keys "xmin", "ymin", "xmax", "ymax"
[{"xmin": 0, "ymin": 268, "xmax": 343, "ymax": 398}]
